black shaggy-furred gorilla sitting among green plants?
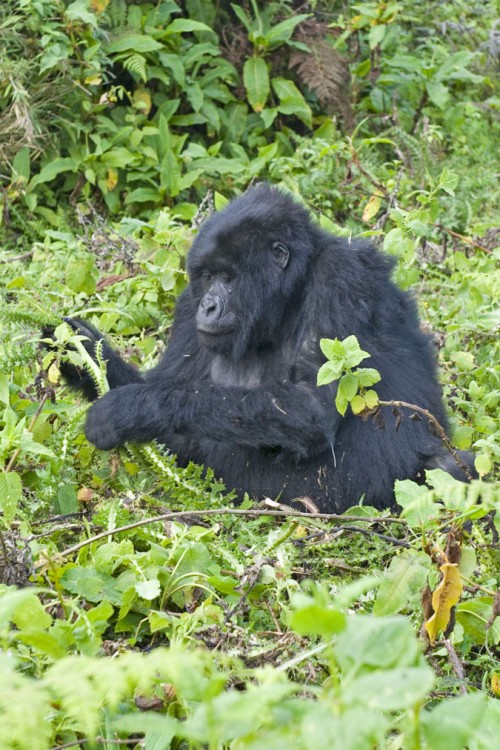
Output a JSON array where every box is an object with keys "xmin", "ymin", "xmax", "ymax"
[{"xmin": 65, "ymin": 185, "xmax": 465, "ymax": 512}]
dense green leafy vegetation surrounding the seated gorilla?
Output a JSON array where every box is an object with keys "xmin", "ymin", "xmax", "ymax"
[{"xmin": 0, "ymin": 0, "xmax": 500, "ymax": 750}]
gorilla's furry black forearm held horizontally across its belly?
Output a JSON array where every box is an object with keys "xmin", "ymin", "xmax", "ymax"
[{"xmin": 85, "ymin": 379, "xmax": 340, "ymax": 460}]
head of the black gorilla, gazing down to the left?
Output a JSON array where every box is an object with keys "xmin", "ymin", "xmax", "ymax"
[{"xmin": 188, "ymin": 185, "xmax": 318, "ymax": 360}]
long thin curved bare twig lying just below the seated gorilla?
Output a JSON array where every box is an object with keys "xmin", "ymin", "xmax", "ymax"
[{"xmin": 35, "ymin": 508, "xmax": 406, "ymax": 570}]
